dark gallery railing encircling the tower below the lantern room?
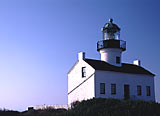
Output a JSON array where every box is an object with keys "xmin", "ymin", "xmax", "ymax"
[{"xmin": 97, "ymin": 39, "xmax": 126, "ymax": 51}]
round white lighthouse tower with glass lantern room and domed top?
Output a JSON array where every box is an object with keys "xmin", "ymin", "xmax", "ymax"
[{"xmin": 97, "ymin": 19, "xmax": 126, "ymax": 66}]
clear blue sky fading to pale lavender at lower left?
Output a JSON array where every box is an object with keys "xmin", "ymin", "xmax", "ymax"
[{"xmin": 0, "ymin": 0, "xmax": 160, "ymax": 111}]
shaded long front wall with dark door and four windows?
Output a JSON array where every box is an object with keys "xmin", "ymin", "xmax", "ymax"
[{"xmin": 95, "ymin": 71, "xmax": 155, "ymax": 101}]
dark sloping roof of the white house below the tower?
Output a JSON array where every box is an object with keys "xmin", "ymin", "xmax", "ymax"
[{"xmin": 85, "ymin": 59, "xmax": 155, "ymax": 76}]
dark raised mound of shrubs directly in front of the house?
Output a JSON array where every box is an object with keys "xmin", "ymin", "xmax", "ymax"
[{"xmin": 62, "ymin": 98, "xmax": 160, "ymax": 116}]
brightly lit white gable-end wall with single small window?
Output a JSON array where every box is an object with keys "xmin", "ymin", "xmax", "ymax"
[{"xmin": 68, "ymin": 60, "xmax": 95, "ymax": 104}]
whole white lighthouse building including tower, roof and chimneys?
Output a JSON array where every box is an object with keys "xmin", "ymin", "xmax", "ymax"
[{"xmin": 68, "ymin": 19, "xmax": 155, "ymax": 105}]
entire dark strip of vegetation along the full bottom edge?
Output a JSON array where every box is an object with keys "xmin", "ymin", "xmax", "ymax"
[{"xmin": 0, "ymin": 98, "xmax": 160, "ymax": 116}]
